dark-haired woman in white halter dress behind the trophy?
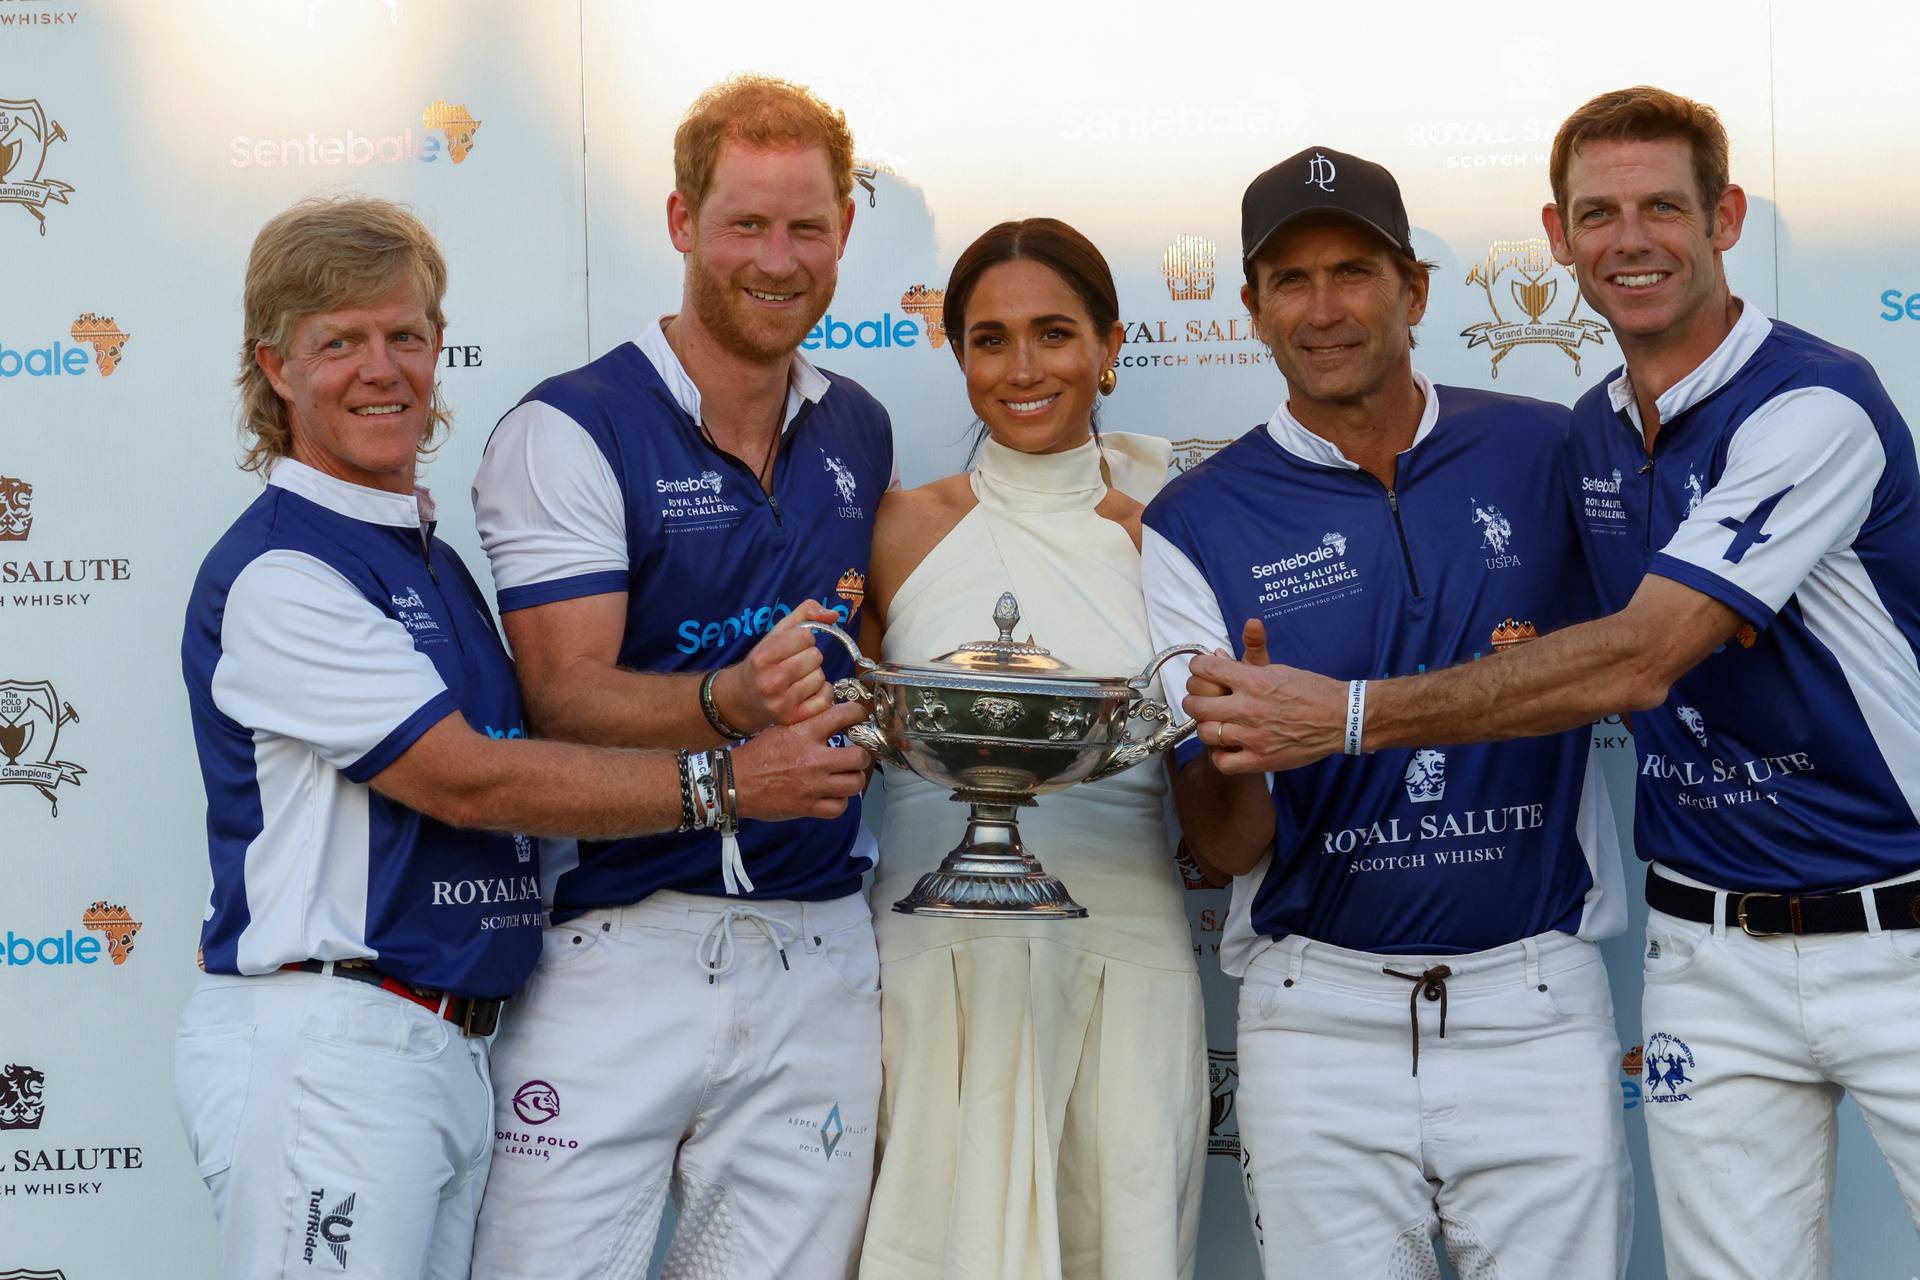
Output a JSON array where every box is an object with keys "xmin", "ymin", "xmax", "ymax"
[{"xmin": 860, "ymin": 219, "xmax": 1208, "ymax": 1280}]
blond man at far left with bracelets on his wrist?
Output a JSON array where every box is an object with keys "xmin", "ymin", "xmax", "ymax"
[{"xmin": 175, "ymin": 198, "xmax": 864, "ymax": 1280}]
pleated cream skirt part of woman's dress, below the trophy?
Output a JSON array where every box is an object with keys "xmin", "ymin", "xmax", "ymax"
[{"xmin": 860, "ymin": 936, "xmax": 1208, "ymax": 1280}]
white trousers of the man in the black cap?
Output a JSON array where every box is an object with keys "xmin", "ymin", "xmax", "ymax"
[{"xmin": 1236, "ymin": 933, "xmax": 1632, "ymax": 1280}]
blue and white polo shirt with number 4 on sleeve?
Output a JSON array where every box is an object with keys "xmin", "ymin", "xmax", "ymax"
[{"xmin": 1569, "ymin": 303, "xmax": 1920, "ymax": 892}]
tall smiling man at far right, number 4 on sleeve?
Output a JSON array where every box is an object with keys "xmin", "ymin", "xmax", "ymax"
[{"xmin": 1188, "ymin": 86, "xmax": 1920, "ymax": 1280}]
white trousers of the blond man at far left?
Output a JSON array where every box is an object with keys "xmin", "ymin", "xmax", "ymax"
[{"xmin": 175, "ymin": 973, "xmax": 493, "ymax": 1280}]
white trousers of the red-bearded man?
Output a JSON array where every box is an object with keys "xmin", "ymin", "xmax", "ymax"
[{"xmin": 472, "ymin": 892, "xmax": 879, "ymax": 1280}]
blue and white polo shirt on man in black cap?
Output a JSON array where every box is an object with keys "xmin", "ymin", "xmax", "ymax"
[{"xmin": 1140, "ymin": 372, "xmax": 1626, "ymax": 973}]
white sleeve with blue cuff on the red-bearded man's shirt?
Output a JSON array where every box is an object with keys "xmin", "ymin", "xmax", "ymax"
[{"xmin": 474, "ymin": 401, "xmax": 628, "ymax": 614}]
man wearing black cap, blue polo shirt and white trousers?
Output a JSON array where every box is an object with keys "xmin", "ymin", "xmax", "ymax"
[{"xmin": 1142, "ymin": 148, "xmax": 1630, "ymax": 1280}]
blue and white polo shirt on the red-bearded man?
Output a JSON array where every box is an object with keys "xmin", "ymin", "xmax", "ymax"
[{"xmin": 474, "ymin": 324, "xmax": 895, "ymax": 919}]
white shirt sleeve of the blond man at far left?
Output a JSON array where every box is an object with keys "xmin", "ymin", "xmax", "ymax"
[{"xmin": 213, "ymin": 551, "xmax": 457, "ymax": 783}]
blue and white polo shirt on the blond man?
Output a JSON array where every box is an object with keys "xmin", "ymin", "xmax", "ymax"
[{"xmin": 180, "ymin": 459, "xmax": 543, "ymax": 998}]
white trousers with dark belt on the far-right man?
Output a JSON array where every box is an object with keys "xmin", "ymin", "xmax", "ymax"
[{"xmin": 1642, "ymin": 898, "xmax": 1920, "ymax": 1280}]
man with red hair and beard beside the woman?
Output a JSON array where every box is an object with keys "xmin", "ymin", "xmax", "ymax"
[{"xmin": 474, "ymin": 77, "xmax": 895, "ymax": 1280}]
